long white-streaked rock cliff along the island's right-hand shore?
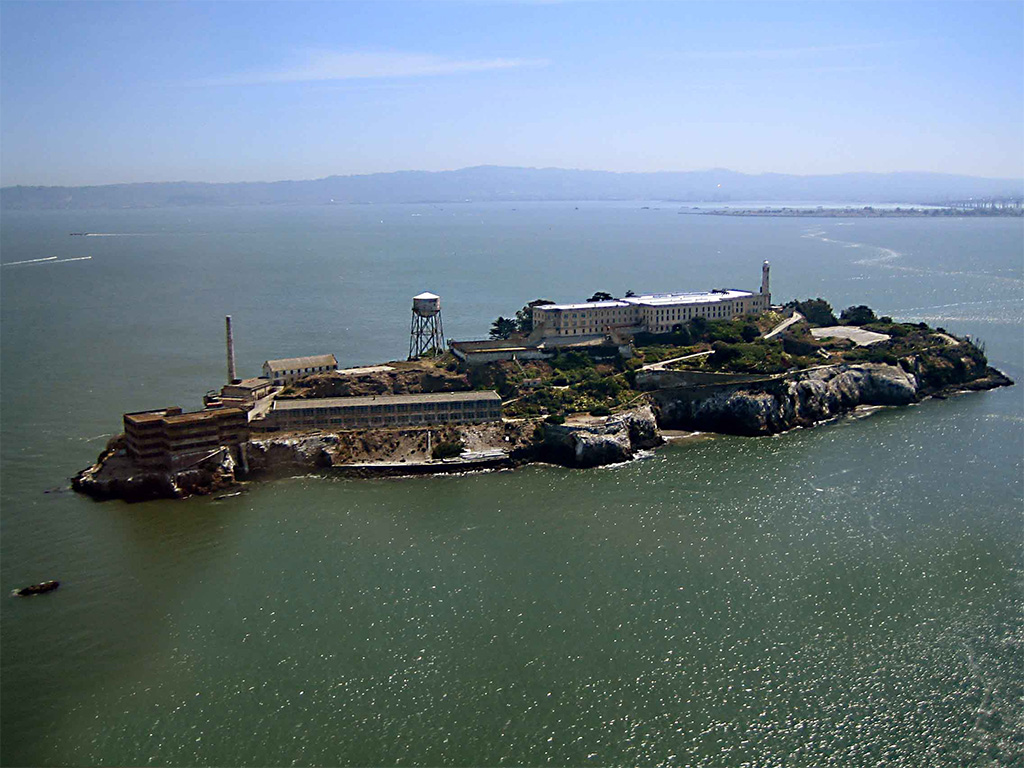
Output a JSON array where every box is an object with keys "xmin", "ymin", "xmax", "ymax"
[{"xmin": 651, "ymin": 362, "xmax": 987, "ymax": 435}]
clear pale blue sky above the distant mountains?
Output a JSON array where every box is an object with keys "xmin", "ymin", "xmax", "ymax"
[{"xmin": 0, "ymin": 0, "xmax": 1024, "ymax": 185}]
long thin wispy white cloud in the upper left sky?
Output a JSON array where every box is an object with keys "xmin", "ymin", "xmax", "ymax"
[{"xmin": 194, "ymin": 50, "xmax": 547, "ymax": 86}]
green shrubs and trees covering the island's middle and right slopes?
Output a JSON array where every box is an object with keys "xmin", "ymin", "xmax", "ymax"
[{"xmin": 450, "ymin": 293, "xmax": 988, "ymax": 418}]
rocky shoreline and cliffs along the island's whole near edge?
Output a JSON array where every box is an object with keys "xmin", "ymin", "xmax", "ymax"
[{"xmin": 72, "ymin": 359, "xmax": 1014, "ymax": 502}]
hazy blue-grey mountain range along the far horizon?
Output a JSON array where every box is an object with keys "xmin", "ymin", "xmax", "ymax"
[{"xmin": 0, "ymin": 166, "xmax": 1024, "ymax": 210}]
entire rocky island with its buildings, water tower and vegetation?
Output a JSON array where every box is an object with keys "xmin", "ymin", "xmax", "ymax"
[{"xmin": 72, "ymin": 261, "xmax": 1013, "ymax": 501}]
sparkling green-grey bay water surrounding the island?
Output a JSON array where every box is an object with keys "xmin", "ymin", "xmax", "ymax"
[{"xmin": 0, "ymin": 204, "xmax": 1024, "ymax": 766}]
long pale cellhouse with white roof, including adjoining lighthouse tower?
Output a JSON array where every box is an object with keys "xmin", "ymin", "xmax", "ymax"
[{"xmin": 531, "ymin": 261, "xmax": 771, "ymax": 339}]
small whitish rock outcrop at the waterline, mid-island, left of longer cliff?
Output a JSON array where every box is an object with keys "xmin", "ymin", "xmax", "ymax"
[{"xmin": 538, "ymin": 406, "xmax": 664, "ymax": 467}]
